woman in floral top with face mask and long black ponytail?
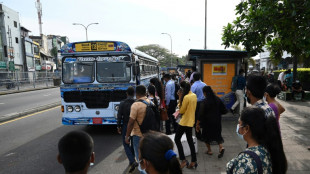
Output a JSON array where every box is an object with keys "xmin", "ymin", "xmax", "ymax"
[{"xmin": 226, "ymin": 106, "xmax": 287, "ymax": 174}]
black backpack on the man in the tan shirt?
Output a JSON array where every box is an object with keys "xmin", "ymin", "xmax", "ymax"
[{"xmin": 136, "ymin": 100, "xmax": 160, "ymax": 134}]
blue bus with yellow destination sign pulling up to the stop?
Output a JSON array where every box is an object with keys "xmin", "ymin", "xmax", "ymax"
[{"xmin": 60, "ymin": 41, "xmax": 159, "ymax": 125}]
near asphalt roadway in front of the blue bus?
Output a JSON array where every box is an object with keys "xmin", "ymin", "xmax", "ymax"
[{"xmin": 0, "ymin": 108, "xmax": 132, "ymax": 174}]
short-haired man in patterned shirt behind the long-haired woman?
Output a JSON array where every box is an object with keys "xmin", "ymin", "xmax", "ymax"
[{"xmin": 246, "ymin": 75, "xmax": 275, "ymax": 117}]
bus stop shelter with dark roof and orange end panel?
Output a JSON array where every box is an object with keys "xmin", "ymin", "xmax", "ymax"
[{"xmin": 188, "ymin": 49, "xmax": 248, "ymax": 97}]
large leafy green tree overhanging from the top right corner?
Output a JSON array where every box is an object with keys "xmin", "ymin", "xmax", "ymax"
[{"xmin": 222, "ymin": 0, "xmax": 310, "ymax": 80}]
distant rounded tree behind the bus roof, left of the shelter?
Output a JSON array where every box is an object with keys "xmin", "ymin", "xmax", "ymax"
[{"xmin": 136, "ymin": 44, "xmax": 185, "ymax": 67}]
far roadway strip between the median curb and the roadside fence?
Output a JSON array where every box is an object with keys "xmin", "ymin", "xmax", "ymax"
[{"xmin": 0, "ymin": 88, "xmax": 60, "ymax": 116}]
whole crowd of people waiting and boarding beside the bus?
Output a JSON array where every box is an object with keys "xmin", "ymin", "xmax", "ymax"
[{"xmin": 58, "ymin": 68, "xmax": 287, "ymax": 174}]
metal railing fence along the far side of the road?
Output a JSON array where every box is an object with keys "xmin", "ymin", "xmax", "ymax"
[{"xmin": 0, "ymin": 72, "xmax": 60, "ymax": 91}]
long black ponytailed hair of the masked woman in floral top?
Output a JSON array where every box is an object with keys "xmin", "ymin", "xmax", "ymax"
[{"xmin": 240, "ymin": 106, "xmax": 287, "ymax": 174}]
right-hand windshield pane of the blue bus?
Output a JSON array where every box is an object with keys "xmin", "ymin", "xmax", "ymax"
[{"xmin": 97, "ymin": 62, "xmax": 130, "ymax": 83}]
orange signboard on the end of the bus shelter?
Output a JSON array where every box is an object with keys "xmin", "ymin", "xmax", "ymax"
[{"xmin": 203, "ymin": 63, "xmax": 235, "ymax": 97}]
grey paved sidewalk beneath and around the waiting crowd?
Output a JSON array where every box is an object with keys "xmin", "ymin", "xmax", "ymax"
[{"xmin": 89, "ymin": 101, "xmax": 310, "ymax": 174}]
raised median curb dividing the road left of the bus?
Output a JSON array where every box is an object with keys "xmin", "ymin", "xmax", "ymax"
[{"xmin": 0, "ymin": 102, "xmax": 61, "ymax": 123}]
